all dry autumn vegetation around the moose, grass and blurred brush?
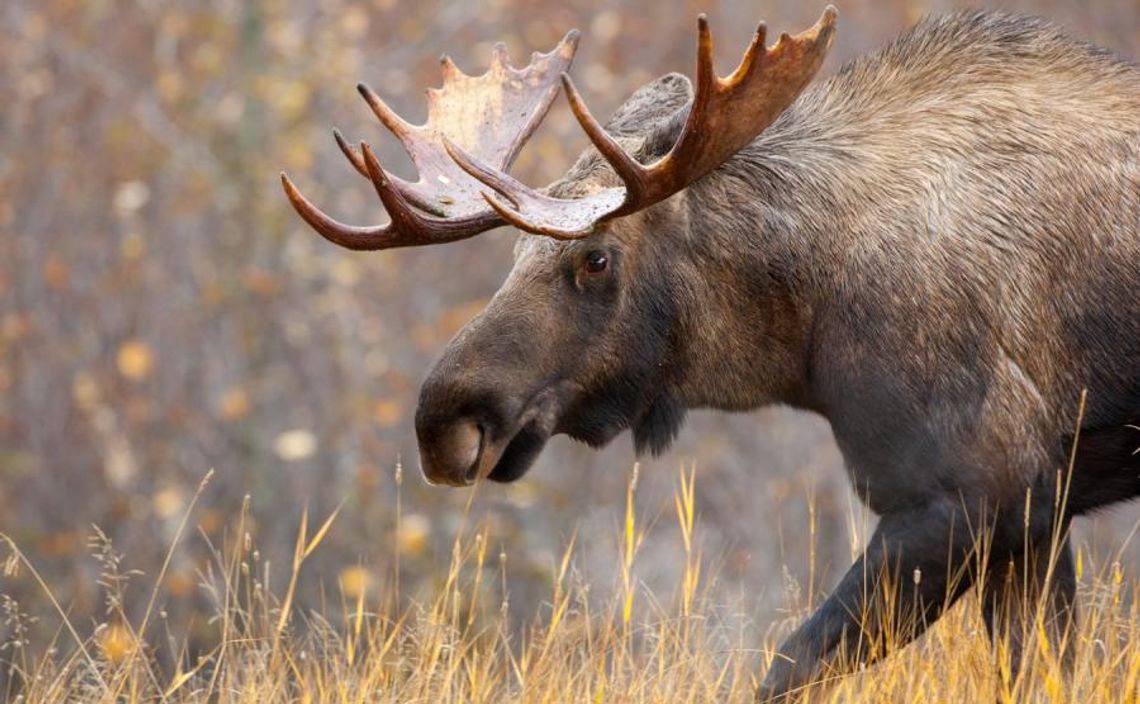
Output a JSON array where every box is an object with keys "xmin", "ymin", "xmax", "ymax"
[{"xmin": 0, "ymin": 0, "xmax": 1140, "ymax": 703}]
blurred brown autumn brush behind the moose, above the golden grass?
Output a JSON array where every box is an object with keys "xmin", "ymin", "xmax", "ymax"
[{"xmin": 0, "ymin": 0, "xmax": 1140, "ymax": 669}]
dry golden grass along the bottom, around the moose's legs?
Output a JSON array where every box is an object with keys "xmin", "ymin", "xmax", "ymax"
[{"xmin": 0, "ymin": 462, "xmax": 1140, "ymax": 704}]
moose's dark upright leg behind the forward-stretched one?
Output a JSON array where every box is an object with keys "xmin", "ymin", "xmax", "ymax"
[{"xmin": 982, "ymin": 537, "xmax": 1076, "ymax": 682}]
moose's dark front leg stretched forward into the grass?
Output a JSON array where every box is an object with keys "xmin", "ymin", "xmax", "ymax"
[{"xmin": 757, "ymin": 499, "xmax": 974, "ymax": 702}]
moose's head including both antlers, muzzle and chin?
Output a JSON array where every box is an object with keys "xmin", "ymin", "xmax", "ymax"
[{"xmin": 282, "ymin": 7, "xmax": 836, "ymax": 485}]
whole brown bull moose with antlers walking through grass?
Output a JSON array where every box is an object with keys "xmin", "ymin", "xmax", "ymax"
[{"xmin": 282, "ymin": 7, "xmax": 1140, "ymax": 699}]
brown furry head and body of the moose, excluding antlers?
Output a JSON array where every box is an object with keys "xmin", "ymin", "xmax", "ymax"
[{"xmin": 417, "ymin": 13, "xmax": 1140, "ymax": 697}]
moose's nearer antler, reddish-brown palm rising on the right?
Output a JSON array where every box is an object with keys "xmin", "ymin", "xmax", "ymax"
[{"xmin": 445, "ymin": 6, "xmax": 838, "ymax": 239}]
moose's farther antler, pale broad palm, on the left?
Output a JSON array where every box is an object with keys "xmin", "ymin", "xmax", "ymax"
[{"xmin": 282, "ymin": 31, "xmax": 578, "ymax": 249}]
